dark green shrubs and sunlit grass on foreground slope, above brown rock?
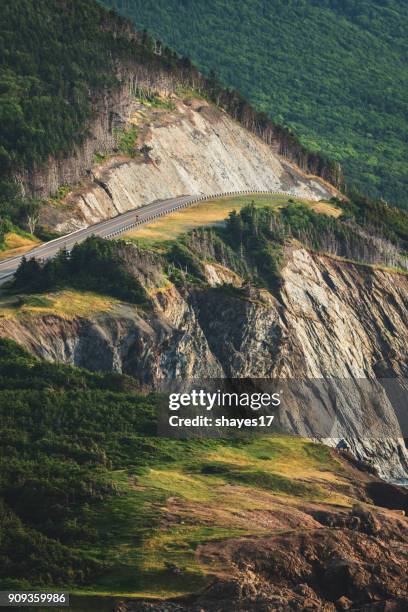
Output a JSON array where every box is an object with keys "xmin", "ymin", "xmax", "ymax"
[{"xmin": 0, "ymin": 340, "xmax": 351, "ymax": 596}]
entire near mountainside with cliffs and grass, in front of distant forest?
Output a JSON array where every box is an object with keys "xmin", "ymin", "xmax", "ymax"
[{"xmin": 0, "ymin": 0, "xmax": 408, "ymax": 612}]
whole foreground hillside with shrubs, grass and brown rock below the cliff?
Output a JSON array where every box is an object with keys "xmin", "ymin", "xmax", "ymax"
[{"xmin": 0, "ymin": 340, "xmax": 408, "ymax": 612}]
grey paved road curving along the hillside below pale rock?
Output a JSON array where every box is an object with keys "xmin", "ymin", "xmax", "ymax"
[{"xmin": 0, "ymin": 191, "xmax": 293, "ymax": 285}]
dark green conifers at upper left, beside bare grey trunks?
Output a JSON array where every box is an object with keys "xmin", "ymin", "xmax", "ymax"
[{"xmin": 0, "ymin": 0, "xmax": 140, "ymax": 225}]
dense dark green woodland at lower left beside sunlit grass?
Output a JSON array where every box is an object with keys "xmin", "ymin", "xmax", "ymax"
[{"xmin": 0, "ymin": 340, "xmax": 155, "ymax": 588}]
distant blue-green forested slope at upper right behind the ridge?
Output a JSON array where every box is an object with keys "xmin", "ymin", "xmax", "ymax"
[{"xmin": 103, "ymin": 0, "xmax": 408, "ymax": 208}]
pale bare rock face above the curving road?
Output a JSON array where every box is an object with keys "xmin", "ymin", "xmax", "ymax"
[{"xmin": 42, "ymin": 98, "xmax": 336, "ymax": 233}]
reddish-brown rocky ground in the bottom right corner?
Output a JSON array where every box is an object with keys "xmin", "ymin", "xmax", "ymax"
[{"xmin": 109, "ymin": 488, "xmax": 408, "ymax": 612}]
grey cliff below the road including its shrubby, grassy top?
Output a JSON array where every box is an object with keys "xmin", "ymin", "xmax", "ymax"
[{"xmin": 0, "ymin": 214, "xmax": 408, "ymax": 479}]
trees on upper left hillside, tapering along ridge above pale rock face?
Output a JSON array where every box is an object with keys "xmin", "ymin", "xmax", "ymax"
[{"xmin": 0, "ymin": 0, "xmax": 342, "ymax": 239}]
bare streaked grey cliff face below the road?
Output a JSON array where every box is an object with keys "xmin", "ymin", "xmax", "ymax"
[{"xmin": 0, "ymin": 247, "xmax": 408, "ymax": 478}]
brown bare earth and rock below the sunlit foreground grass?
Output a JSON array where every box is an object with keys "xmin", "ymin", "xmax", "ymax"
[{"xmin": 195, "ymin": 515, "xmax": 408, "ymax": 610}]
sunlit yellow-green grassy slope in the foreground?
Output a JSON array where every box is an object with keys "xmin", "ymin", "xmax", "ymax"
[{"xmin": 74, "ymin": 436, "xmax": 352, "ymax": 597}]
